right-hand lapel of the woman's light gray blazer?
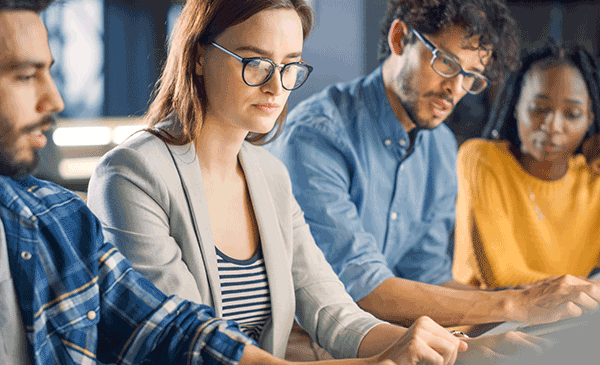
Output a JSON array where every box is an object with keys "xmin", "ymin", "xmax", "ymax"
[{"xmin": 240, "ymin": 142, "xmax": 295, "ymax": 349}]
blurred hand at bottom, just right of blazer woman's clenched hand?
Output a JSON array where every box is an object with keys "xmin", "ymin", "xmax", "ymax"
[{"xmin": 456, "ymin": 331, "xmax": 552, "ymax": 365}]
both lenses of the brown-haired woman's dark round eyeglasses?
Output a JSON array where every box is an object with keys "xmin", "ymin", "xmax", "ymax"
[{"xmin": 243, "ymin": 59, "xmax": 309, "ymax": 90}]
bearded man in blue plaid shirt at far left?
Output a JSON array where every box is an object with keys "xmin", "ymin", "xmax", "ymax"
[{"xmin": 0, "ymin": 0, "xmax": 257, "ymax": 365}]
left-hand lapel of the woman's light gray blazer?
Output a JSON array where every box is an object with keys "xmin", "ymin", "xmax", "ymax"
[{"xmin": 167, "ymin": 143, "xmax": 223, "ymax": 317}]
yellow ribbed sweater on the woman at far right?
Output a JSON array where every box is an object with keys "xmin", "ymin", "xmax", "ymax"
[{"xmin": 453, "ymin": 139, "xmax": 600, "ymax": 287}]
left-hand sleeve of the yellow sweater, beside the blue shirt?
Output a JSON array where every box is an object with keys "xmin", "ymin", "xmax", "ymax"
[{"xmin": 457, "ymin": 140, "xmax": 547, "ymax": 287}]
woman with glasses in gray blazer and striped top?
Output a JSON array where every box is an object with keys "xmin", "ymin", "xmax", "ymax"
[{"xmin": 88, "ymin": 0, "xmax": 485, "ymax": 364}]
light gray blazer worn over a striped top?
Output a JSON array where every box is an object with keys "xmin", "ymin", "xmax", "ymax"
[{"xmin": 88, "ymin": 118, "xmax": 381, "ymax": 358}]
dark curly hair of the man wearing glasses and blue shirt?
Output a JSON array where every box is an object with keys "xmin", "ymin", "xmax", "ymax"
[{"xmin": 379, "ymin": 0, "xmax": 520, "ymax": 80}]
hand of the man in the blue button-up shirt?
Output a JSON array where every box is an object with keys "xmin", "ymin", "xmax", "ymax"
[{"xmin": 515, "ymin": 275, "xmax": 600, "ymax": 324}]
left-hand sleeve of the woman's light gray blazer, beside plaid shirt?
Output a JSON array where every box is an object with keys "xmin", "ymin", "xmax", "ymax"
[{"xmin": 87, "ymin": 147, "xmax": 204, "ymax": 303}]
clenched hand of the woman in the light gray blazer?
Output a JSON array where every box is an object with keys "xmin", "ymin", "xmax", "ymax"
[{"xmin": 370, "ymin": 317, "xmax": 467, "ymax": 365}]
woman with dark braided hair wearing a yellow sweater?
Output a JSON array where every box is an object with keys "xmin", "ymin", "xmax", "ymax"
[{"xmin": 454, "ymin": 45, "xmax": 600, "ymax": 288}]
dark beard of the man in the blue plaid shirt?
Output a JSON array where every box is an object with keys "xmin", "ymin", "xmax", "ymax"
[{"xmin": 0, "ymin": 116, "xmax": 55, "ymax": 179}]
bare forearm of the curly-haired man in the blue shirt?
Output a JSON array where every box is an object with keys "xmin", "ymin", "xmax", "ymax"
[{"xmin": 358, "ymin": 278, "xmax": 517, "ymax": 326}]
